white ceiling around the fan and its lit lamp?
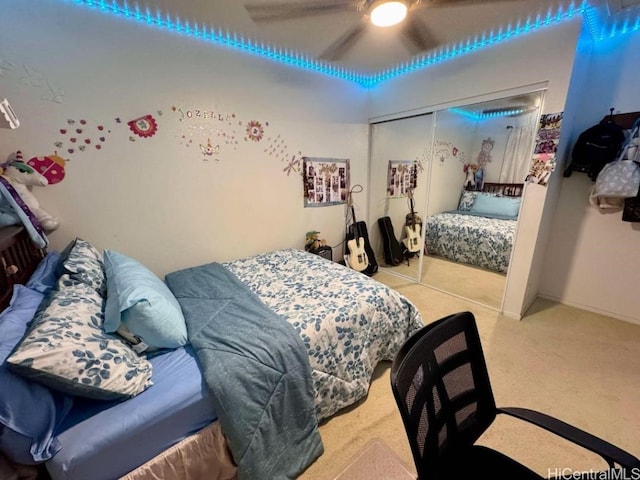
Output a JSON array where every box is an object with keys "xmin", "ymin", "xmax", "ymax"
[{"xmin": 119, "ymin": 0, "xmax": 638, "ymax": 73}]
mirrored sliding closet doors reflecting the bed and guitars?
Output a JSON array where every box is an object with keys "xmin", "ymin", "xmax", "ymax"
[{"xmin": 369, "ymin": 91, "xmax": 543, "ymax": 309}]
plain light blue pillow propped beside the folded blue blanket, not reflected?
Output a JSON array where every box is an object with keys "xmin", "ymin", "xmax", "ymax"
[{"xmin": 103, "ymin": 250, "xmax": 188, "ymax": 351}]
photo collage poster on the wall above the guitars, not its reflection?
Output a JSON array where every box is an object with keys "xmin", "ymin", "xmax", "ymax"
[{"xmin": 302, "ymin": 157, "xmax": 350, "ymax": 207}]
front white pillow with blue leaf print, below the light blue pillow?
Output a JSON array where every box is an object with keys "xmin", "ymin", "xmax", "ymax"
[{"xmin": 7, "ymin": 275, "xmax": 152, "ymax": 400}]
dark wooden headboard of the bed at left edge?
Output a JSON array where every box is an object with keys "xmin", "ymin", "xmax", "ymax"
[{"xmin": 0, "ymin": 225, "xmax": 45, "ymax": 311}]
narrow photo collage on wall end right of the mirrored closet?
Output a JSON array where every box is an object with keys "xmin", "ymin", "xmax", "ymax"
[{"xmin": 525, "ymin": 112, "xmax": 563, "ymax": 186}]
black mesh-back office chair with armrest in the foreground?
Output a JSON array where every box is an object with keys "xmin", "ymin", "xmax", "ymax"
[{"xmin": 391, "ymin": 312, "xmax": 640, "ymax": 480}]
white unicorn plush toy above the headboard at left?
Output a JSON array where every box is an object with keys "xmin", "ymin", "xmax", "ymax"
[{"xmin": 0, "ymin": 152, "xmax": 60, "ymax": 232}]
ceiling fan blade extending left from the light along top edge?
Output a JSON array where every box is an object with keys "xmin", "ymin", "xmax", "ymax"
[{"xmin": 244, "ymin": 0, "xmax": 358, "ymax": 22}]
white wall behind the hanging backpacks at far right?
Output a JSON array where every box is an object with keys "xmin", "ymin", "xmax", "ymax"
[{"xmin": 540, "ymin": 34, "xmax": 640, "ymax": 323}]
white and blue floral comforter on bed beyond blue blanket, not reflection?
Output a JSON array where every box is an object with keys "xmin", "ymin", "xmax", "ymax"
[{"xmin": 222, "ymin": 249, "xmax": 424, "ymax": 421}]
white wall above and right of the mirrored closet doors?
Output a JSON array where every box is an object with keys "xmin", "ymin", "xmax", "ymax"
[{"xmin": 370, "ymin": 17, "xmax": 582, "ymax": 318}]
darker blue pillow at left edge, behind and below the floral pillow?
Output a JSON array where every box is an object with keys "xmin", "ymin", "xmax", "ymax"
[{"xmin": 0, "ymin": 285, "xmax": 73, "ymax": 464}]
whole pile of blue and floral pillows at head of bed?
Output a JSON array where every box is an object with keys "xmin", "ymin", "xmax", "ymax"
[{"xmin": 0, "ymin": 238, "xmax": 188, "ymax": 464}]
